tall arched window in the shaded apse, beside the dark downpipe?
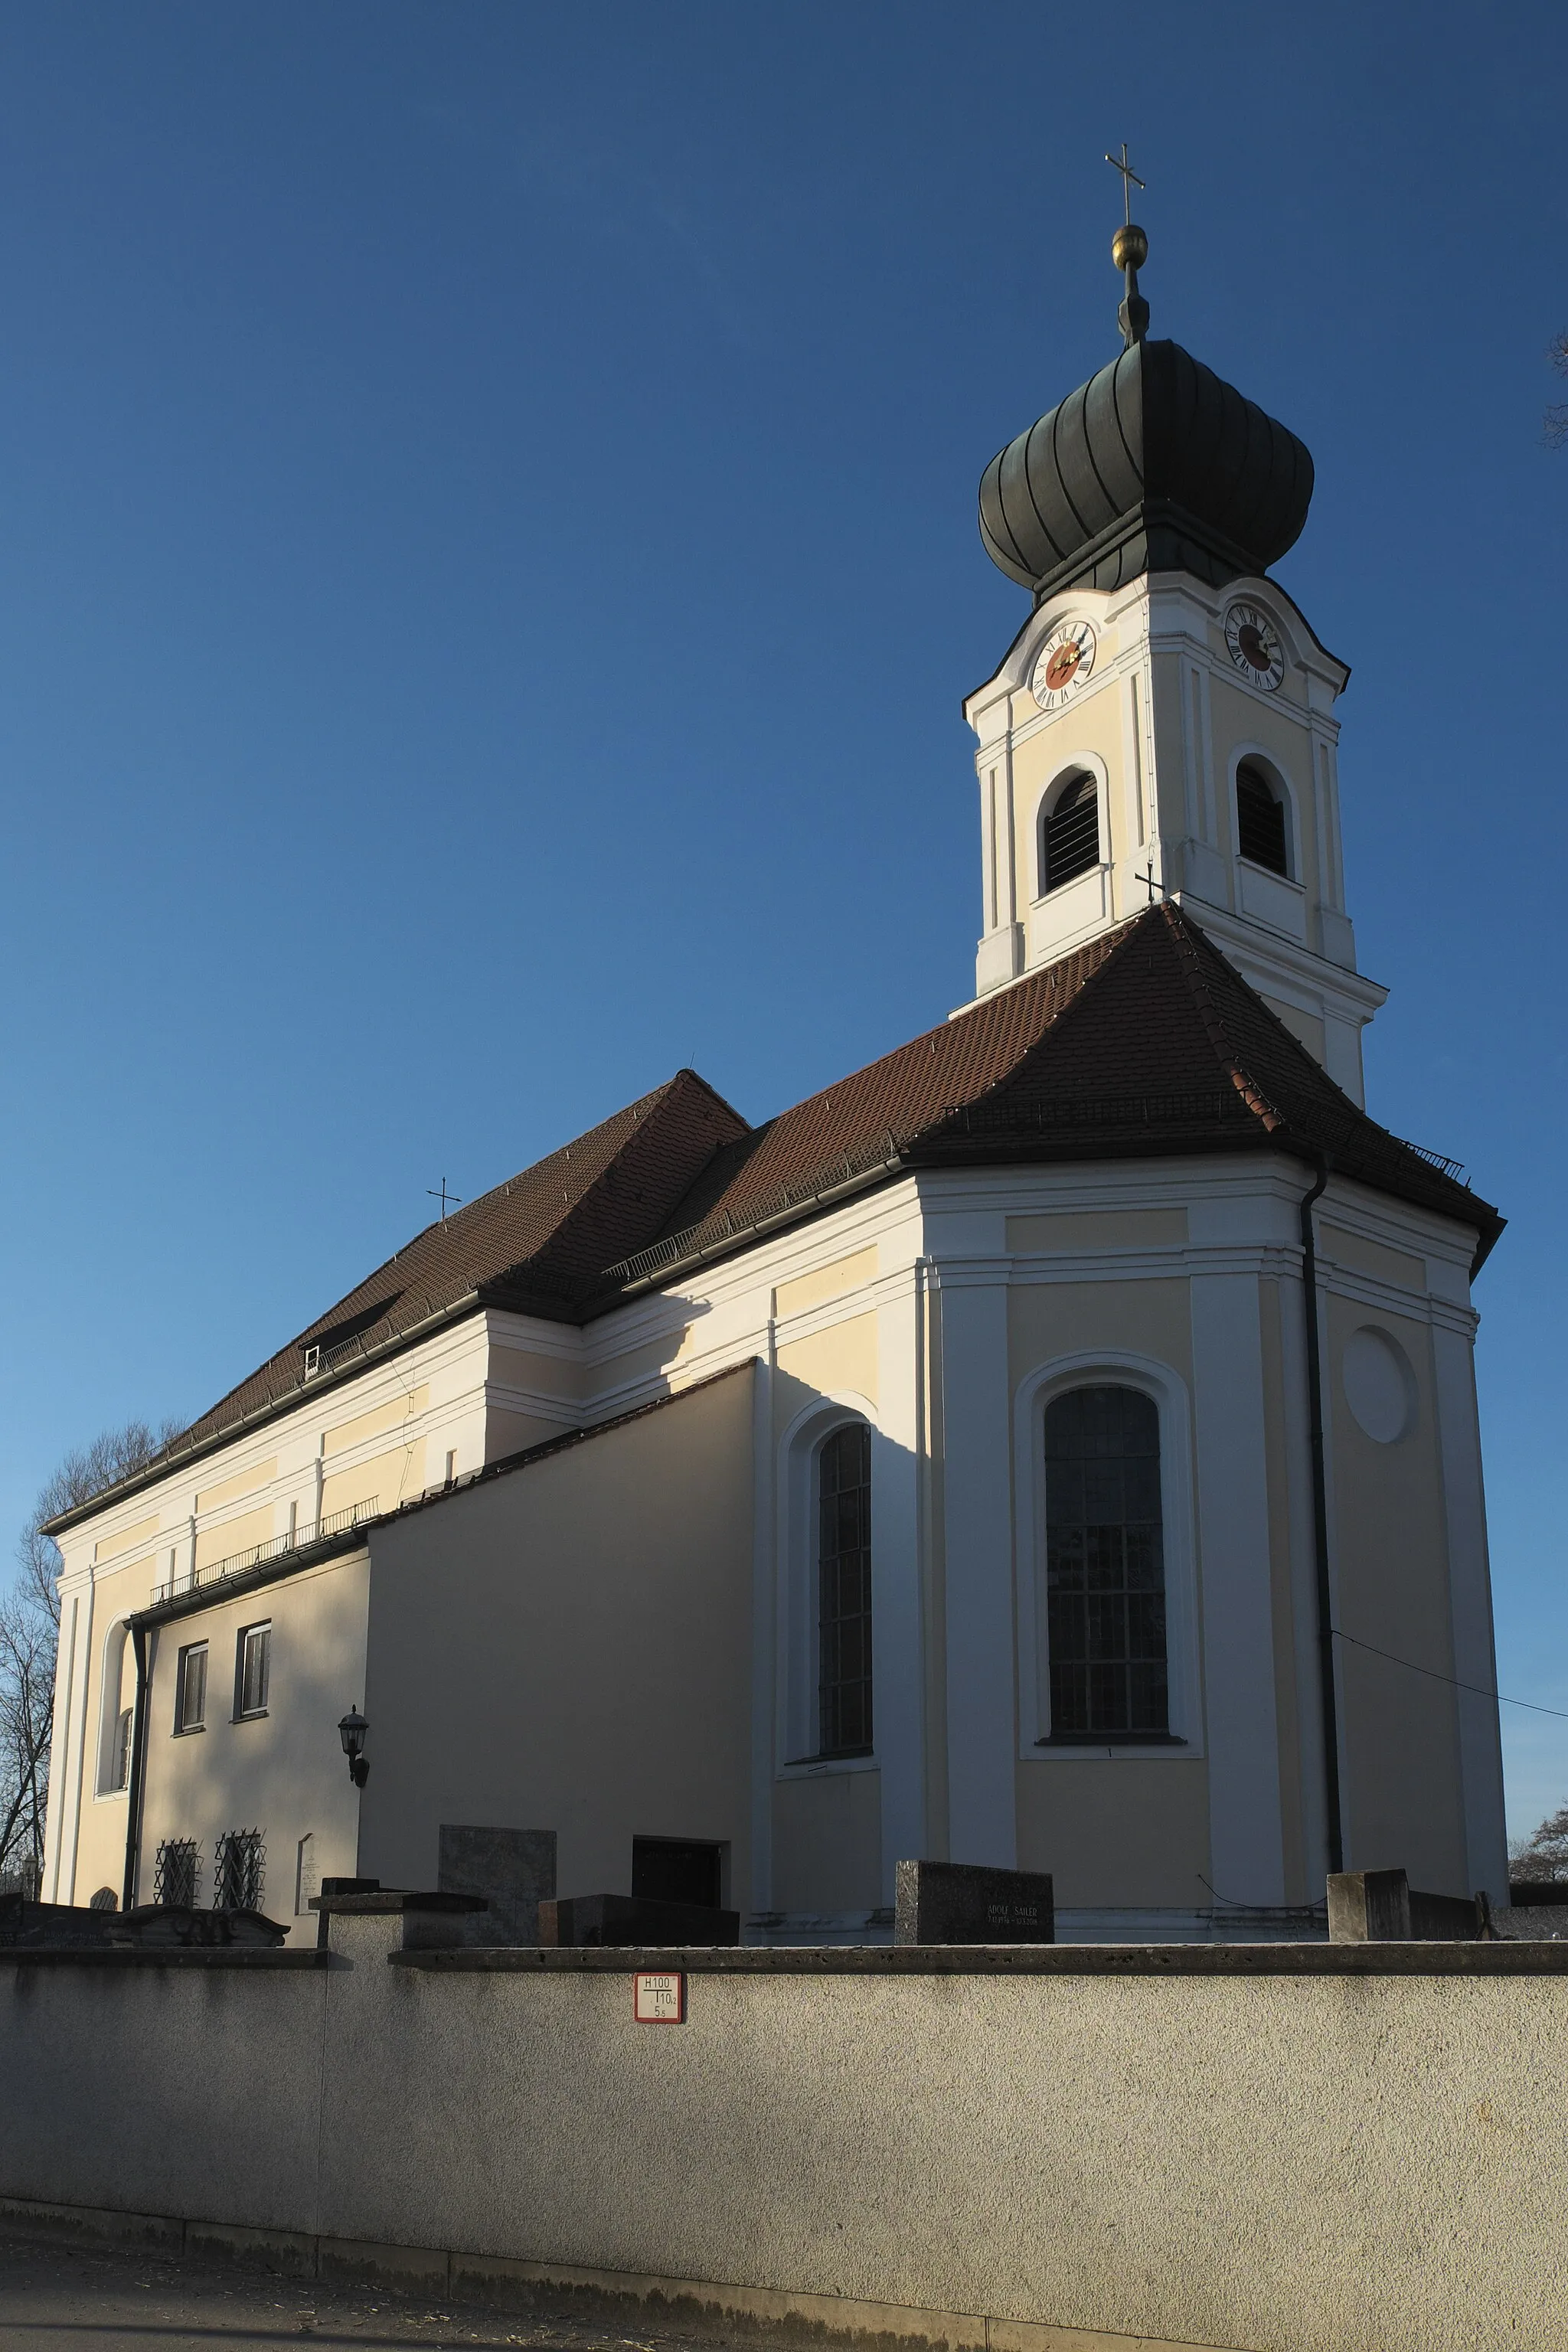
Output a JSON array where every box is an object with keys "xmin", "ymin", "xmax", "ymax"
[{"xmin": 1046, "ymin": 1387, "xmax": 1171, "ymax": 1740}]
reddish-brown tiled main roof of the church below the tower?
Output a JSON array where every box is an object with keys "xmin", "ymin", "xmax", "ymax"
[{"xmin": 59, "ymin": 906, "xmax": 1502, "ymax": 1524}]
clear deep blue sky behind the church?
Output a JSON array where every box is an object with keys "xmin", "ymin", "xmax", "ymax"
[{"xmin": 0, "ymin": 0, "xmax": 1568, "ymax": 1828}]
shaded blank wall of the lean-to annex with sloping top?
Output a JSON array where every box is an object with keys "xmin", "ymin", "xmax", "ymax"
[{"xmin": 360, "ymin": 1367, "xmax": 753, "ymax": 1896}]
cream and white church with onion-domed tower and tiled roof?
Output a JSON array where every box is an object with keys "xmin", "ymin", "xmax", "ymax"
[{"xmin": 42, "ymin": 226, "xmax": 1507, "ymax": 1942}]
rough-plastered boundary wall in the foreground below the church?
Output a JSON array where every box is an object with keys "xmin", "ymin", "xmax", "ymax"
[{"xmin": 0, "ymin": 1915, "xmax": 1568, "ymax": 2352}]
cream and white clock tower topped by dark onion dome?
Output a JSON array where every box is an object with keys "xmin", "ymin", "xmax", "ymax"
[{"xmin": 964, "ymin": 221, "xmax": 1387, "ymax": 1106}]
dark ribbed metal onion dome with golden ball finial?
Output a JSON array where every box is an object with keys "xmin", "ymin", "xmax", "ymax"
[{"xmin": 980, "ymin": 200, "xmax": 1312, "ymax": 602}]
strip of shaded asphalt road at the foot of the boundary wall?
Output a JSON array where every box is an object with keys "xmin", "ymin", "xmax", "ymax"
[{"xmin": 0, "ymin": 2230, "xmax": 717, "ymax": 2352}]
